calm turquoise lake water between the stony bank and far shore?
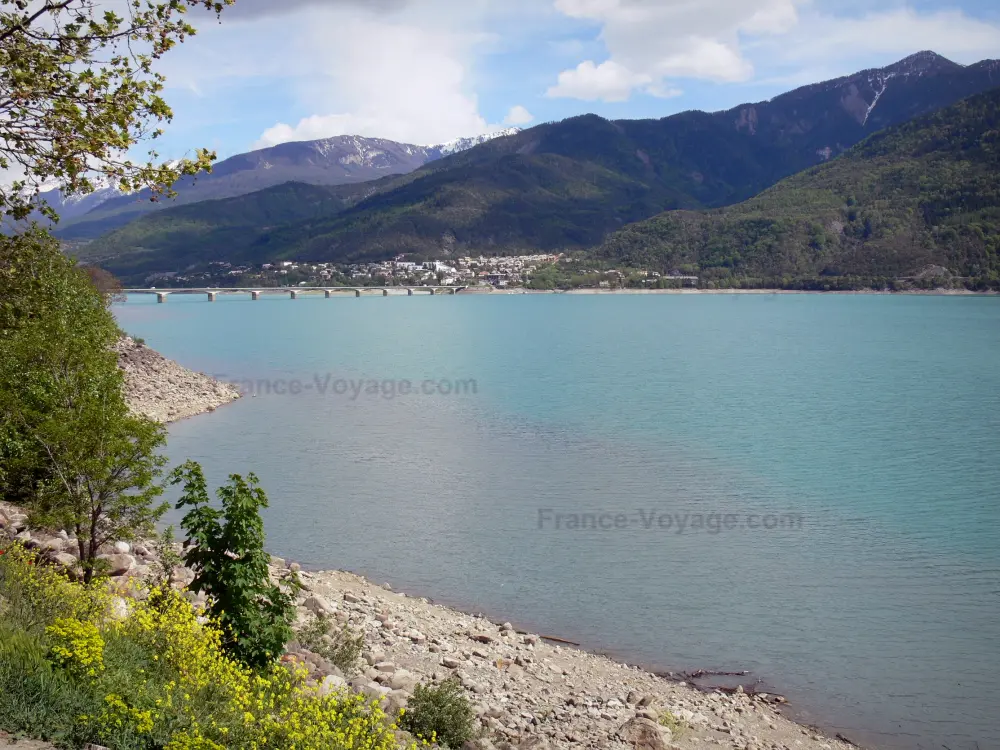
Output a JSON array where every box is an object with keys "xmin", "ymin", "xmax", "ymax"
[{"xmin": 117, "ymin": 295, "xmax": 1000, "ymax": 750}]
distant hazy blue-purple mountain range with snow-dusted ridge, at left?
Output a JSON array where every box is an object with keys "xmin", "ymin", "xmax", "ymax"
[{"xmin": 41, "ymin": 128, "xmax": 519, "ymax": 239}]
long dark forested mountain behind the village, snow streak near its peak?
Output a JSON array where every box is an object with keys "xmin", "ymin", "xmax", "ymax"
[{"xmin": 86, "ymin": 52, "xmax": 1000, "ymax": 282}]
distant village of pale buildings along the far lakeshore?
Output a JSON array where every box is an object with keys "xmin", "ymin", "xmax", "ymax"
[{"xmin": 156, "ymin": 254, "xmax": 697, "ymax": 289}]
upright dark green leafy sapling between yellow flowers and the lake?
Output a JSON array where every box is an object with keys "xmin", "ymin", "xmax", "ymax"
[{"xmin": 171, "ymin": 461, "xmax": 295, "ymax": 667}]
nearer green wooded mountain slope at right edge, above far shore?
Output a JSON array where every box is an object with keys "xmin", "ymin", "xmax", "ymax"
[{"xmin": 596, "ymin": 89, "xmax": 1000, "ymax": 288}]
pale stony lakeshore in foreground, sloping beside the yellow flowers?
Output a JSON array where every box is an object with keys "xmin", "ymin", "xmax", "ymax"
[{"xmin": 0, "ymin": 494, "xmax": 852, "ymax": 750}]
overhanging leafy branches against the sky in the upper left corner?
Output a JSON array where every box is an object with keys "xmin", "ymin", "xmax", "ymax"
[{"xmin": 0, "ymin": 0, "xmax": 234, "ymax": 219}]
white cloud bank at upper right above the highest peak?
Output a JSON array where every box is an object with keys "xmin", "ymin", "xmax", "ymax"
[{"xmin": 549, "ymin": 0, "xmax": 1000, "ymax": 101}]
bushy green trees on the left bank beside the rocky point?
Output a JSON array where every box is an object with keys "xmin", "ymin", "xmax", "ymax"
[{"xmin": 0, "ymin": 230, "xmax": 166, "ymax": 583}]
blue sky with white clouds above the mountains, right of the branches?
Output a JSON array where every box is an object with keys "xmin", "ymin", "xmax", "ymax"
[{"xmin": 146, "ymin": 0, "xmax": 1000, "ymax": 158}]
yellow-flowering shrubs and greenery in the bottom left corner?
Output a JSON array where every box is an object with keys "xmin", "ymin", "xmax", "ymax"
[{"xmin": 0, "ymin": 547, "xmax": 414, "ymax": 750}]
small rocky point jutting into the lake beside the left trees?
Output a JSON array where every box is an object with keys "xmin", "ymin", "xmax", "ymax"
[{"xmin": 115, "ymin": 336, "xmax": 240, "ymax": 423}]
